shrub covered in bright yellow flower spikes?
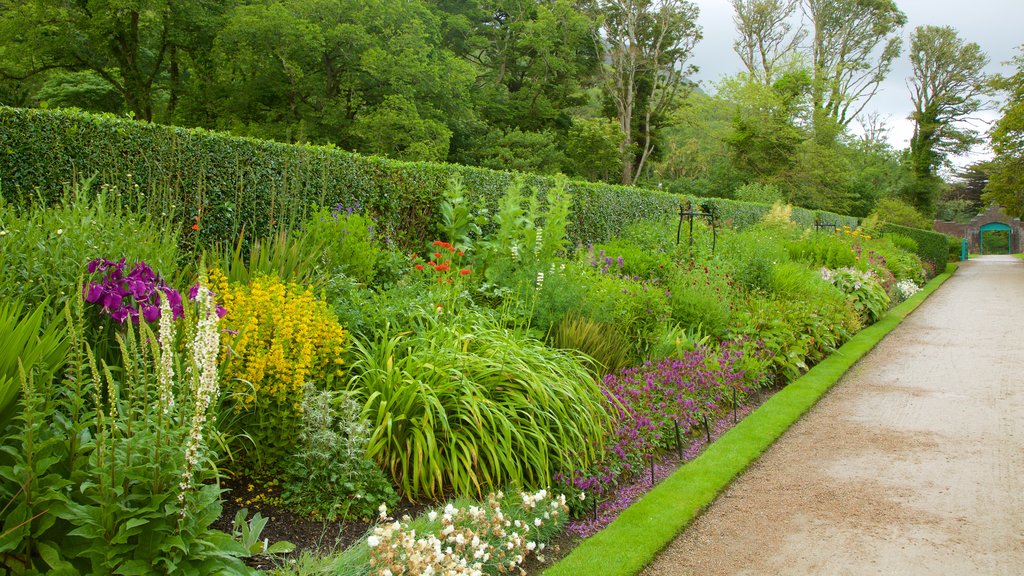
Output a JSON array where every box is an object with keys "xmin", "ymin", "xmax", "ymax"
[{"xmin": 210, "ymin": 270, "xmax": 347, "ymax": 470}]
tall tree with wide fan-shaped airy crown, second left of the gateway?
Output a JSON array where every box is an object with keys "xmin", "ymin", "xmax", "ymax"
[{"xmin": 801, "ymin": 0, "xmax": 906, "ymax": 135}]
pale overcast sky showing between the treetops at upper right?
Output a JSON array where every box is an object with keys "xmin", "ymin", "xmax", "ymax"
[{"xmin": 692, "ymin": 0, "xmax": 1024, "ymax": 163}]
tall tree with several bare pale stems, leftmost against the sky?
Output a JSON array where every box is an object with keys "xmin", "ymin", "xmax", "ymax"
[{"xmin": 591, "ymin": 0, "xmax": 701, "ymax": 184}]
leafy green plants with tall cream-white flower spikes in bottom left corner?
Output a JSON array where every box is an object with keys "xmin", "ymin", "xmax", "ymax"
[{"xmin": 0, "ymin": 291, "xmax": 251, "ymax": 576}]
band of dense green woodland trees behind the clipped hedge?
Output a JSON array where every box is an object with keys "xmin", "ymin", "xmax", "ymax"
[{"xmin": 0, "ymin": 0, "xmax": 999, "ymax": 220}]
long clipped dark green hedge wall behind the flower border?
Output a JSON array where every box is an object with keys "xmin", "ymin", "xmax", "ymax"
[{"xmin": 0, "ymin": 107, "xmax": 856, "ymax": 248}]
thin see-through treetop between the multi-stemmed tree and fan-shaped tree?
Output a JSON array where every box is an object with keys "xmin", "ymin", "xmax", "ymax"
[{"xmin": 731, "ymin": 0, "xmax": 807, "ymax": 85}]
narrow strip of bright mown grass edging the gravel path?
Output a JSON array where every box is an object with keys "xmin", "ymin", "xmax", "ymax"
[{"xmin": 544, "ymin": 264, "xmax": 956, "ymax": 576}]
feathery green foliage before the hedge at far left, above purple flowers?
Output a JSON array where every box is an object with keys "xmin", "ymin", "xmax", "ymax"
[{"xmin": 0, "ymin": 180, "xmax": 178, "ymax": 319}]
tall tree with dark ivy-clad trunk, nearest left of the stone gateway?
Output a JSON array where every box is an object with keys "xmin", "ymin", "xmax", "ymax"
[{"xmin": 908, "ymin": 26, "xmax": 988, "ymax": 214}]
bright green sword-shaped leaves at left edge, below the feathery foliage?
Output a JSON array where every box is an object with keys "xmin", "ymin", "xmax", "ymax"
[{"xmin": 0, "ymin": 300, "xmax": 69, "ymax": 426}]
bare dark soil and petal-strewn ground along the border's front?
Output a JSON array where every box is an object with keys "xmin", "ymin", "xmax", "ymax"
[{"xmin": 213, "ymin": 390, "xmax": 774, "ymax": 574}]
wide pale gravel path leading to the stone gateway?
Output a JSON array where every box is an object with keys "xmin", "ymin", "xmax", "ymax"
[{"xmin": 643, "ymin": 256, "xmax": 1024, "ymax": 576}]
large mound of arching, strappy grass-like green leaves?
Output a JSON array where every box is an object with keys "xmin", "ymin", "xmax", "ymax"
[{"xmin": 348, "ymin": 312, "xmax": 607, "ymax": 499}]
